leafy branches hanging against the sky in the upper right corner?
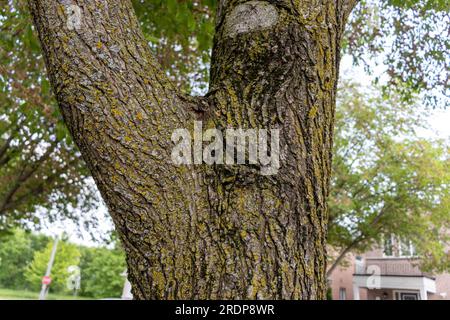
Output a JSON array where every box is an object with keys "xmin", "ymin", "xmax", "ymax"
[{"xmin": 344, "ymin": 0, "xmax": 450, "ymax": 107}]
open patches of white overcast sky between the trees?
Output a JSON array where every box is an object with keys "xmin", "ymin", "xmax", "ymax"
[{"xmin": 43, "ymin": 56, "xmax": 450, "ymax": 246}]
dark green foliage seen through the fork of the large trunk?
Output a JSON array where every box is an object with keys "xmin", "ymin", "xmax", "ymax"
[{"xmin": 133, "ymin": 0, "xmax": 216, "ymax": 93}]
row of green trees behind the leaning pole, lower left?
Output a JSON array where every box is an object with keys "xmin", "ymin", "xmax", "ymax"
[{"xmin": 0, "ymin": 229, "xmax": 126, "ymax": 298}]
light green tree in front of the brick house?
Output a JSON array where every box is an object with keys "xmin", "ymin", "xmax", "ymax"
[{"xmin": 328, "ymin": 84, "xmax": 450, "ymax": 274}]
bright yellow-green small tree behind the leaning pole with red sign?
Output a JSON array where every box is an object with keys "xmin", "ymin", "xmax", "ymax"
[{"xmin": 25, "ymin": 241, "xmax": 81, "ymax": 292}]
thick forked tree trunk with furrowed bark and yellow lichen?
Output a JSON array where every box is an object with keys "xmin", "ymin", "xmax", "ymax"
[{"xmin": 29, "ymin": 0, "xmax": 355, "ymax": 299}]
